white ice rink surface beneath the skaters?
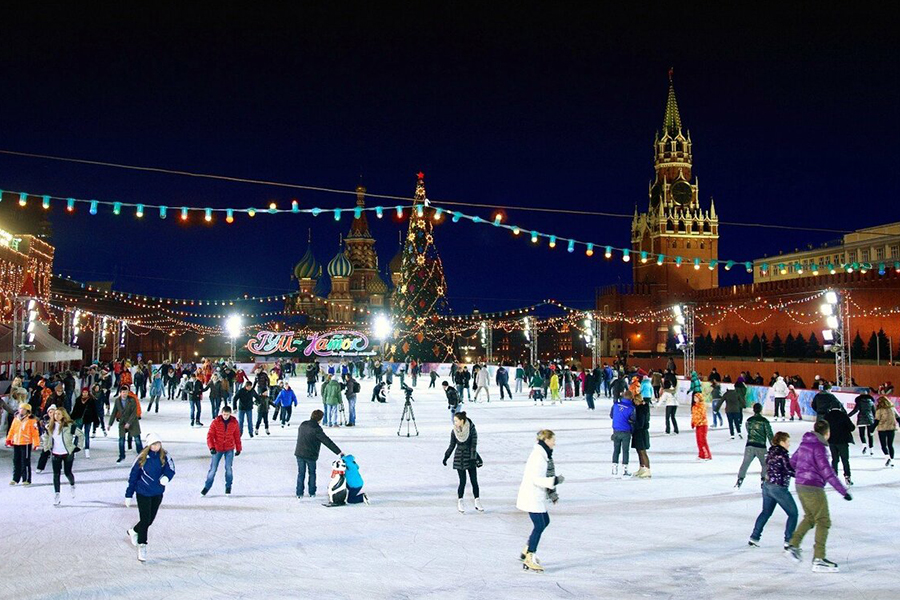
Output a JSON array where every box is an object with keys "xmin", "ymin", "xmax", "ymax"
[{"xmin": 0, "ymin": 380, "xmax": 900, "ymax": 600}]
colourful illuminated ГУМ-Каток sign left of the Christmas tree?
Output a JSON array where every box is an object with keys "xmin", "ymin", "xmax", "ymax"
[{"xmin": 245, "ymin": 330, "xmax": 375, "ymax": 357}]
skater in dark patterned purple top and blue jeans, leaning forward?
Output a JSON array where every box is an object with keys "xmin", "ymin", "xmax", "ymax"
[{"xmin": 747, "ymin": 432, "xmax": 797, "ymax": 550}]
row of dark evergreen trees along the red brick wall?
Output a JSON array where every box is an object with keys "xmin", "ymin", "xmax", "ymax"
[{"xmin": 667, "ymin": 329, "xmax": 900, "ymax": 362}]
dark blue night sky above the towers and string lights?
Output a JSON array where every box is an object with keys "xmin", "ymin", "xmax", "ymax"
[{"xmin": 0, "ymin": 3, "xmax": 900, "ymax": 312}]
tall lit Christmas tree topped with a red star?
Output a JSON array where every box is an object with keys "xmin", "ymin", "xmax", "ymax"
[{"xmin": 393, "ymin": 173, "xmax": 453, "ymax": 362}]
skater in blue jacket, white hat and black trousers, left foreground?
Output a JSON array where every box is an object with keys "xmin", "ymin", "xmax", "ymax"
[{"xmin": 125, "ymin": 433, "xmax": 175, "ymax": 562}]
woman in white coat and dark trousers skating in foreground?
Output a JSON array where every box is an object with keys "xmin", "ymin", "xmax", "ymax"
[{"xmin": 516, "ymin": 429, "xmax": 565, "ymax": 571}]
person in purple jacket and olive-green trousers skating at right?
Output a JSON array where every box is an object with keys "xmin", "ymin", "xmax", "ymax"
[{"xmin": 784, "ymin": 421, "xmax": 853, "ymax": 573}]
